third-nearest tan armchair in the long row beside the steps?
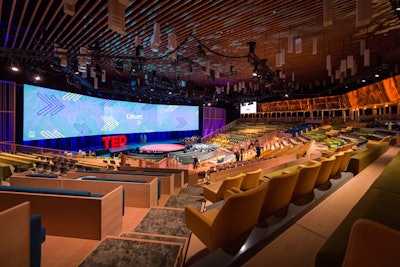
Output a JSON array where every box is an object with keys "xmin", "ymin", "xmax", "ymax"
[{"xmin": 292, "ymin": 160, "xmax": 321, "ymax": 200}]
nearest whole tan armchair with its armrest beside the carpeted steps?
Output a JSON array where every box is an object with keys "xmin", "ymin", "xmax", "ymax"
[{"xmin": 185, "ymin": 183, "xmax": 267, "ymax": 251}]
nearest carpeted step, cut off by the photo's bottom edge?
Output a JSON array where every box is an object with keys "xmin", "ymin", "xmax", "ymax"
[{"xmin": 79, "ymin": 238, "xmax": 182, "ymax": 267}]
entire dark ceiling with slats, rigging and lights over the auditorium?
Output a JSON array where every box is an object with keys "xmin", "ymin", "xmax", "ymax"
[{"xmin": 0, "ymin": 0, "xmax": 400, "ymax": 105}]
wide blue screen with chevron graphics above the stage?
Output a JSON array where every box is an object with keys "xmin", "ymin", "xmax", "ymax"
[{"xmin": 23, "ymin": 85, "xmax": 199, "ymax": 141}]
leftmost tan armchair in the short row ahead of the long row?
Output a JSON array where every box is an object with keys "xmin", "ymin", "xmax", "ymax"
[{"xmin": 203, "ymin": 173, "xmax": 243, "ymax": 203}]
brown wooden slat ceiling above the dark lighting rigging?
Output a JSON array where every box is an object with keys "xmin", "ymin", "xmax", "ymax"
[{"xmin": 0, "ymin": 0, "xmax": 400, "ymax": 103}]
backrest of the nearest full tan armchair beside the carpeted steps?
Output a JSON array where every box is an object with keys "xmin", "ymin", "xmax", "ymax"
[{"xmin": 209, "ymin": 183, "xmax": 268, "ymax": 250}]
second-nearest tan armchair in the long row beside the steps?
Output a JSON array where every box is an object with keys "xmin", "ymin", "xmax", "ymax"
[{"xmin": 260, "ymin": 170, "xmax": 299, "ymax": 220}]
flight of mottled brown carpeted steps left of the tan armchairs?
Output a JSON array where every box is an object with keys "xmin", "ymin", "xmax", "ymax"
[{"xmin": 79, "ymin": 187, "xmax": 204, "ymax": 267}]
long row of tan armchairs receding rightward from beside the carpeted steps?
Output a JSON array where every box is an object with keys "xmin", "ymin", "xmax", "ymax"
[{"xmin": 185, "ymin": 150, "xmax": 352, "ymax": 251}]
